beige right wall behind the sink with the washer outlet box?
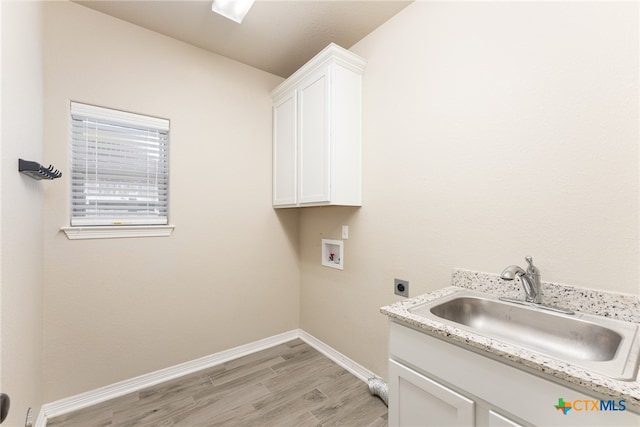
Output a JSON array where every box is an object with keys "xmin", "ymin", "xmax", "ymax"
[{"xmin": 300, "ymin": 2, "xmax": 640, "ymax": 382}]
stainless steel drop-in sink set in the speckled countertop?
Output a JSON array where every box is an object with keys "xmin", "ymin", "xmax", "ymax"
[{"xmin": 409, "ymin": 291, "xmax": 640, "ymax": 380}]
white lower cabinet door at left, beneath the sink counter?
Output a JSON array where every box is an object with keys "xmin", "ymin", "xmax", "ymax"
[{"xmin": 389, "ymin": 360, "xmax": 475, "ymax": 427}]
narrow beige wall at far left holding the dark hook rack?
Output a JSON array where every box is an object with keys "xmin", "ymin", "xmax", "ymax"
[{"xmin": 0, "ymin": 1, "xmax": 44, "ymax": 426}]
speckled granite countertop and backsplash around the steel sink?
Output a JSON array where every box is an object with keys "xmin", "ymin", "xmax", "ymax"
[{"xmin": 380, "ymin": 269, "xmax": 640, "ymax": 411}]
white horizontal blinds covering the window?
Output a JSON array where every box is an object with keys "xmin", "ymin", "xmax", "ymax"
[{"xmin": 71, "ymin": 102, "xmax": 169, "ymax": 226}]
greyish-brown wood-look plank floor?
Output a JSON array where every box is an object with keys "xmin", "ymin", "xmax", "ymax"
[{"xmin": 47, "ymin": 339, "xmax": 387, "ymax": 427}]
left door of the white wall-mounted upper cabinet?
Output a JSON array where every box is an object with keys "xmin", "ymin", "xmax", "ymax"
[{"xmin": 273, "ymin": 90, "xmax": 297, "ymax": 206}]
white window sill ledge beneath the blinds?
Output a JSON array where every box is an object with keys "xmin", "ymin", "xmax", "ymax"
[{"xmin": 61, "ymin": 225, "xmax": 175, "ymax": 240}]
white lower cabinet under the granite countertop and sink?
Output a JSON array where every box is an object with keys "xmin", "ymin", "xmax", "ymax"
[{"xmin": 389, "ymin": 321, "xmax": 640, "ymax": 427}]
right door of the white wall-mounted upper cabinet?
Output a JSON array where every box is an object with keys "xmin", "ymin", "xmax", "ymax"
[{"xmin": 298, "ymin": 68, "xmax": 331, "ymax": 204}]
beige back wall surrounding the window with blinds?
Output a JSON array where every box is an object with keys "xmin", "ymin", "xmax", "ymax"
[{"xmin": 44, "ymin": 2, "xmax": 299, "ymax": 401}]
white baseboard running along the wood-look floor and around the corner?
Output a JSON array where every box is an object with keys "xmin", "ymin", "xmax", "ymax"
[{"xmin": 35, "ymin": 329, "xmax": 376, "ymax": 427}]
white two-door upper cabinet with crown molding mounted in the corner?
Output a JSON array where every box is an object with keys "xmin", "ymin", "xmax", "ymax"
[{"xmin": 271, "ymin": 44, "xmax": 366, "ymax": 208}]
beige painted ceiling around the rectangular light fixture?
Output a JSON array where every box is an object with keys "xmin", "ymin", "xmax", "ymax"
[{"xmin": 74, "ymin": 0, "xmax": 413, "ymax": 77}]
